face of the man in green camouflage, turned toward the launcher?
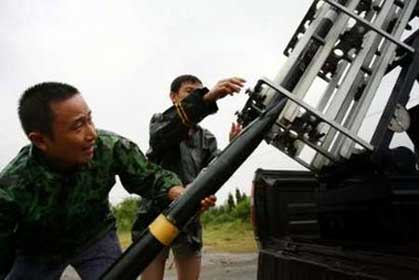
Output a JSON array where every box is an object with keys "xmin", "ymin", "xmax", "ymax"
[{"xmin": 37, "ymin": 94, "xmax": 97, "ymax": 168}]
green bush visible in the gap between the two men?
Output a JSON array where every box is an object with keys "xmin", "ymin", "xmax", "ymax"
[{"xmin": 111, "ymin": 197, "xmax": 141, "ymax": 231}]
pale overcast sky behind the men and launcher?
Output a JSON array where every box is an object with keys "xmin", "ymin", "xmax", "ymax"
[{"xmin": 0, "ymin": 0, "xmax": 416, "ymax": 203}]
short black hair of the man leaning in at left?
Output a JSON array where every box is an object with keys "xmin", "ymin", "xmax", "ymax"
[{"xmin": 18, "ymin": 82, "xmax": 79, "ymax": 137}]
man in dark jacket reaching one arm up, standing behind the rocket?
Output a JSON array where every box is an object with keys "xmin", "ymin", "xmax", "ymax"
[{"xmin": 133, "ymin": 75, "xmax": 244, "ymax": 280}]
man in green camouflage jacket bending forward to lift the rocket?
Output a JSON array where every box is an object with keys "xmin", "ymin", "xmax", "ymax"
[{"xmin": 0, "ymin": 83, "xmax": 214, "ymax": 279}]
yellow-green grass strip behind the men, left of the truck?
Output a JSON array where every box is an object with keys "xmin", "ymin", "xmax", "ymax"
[{"xmin": 118, "ymin": 221, "xmax": 256, "ymax": 253}]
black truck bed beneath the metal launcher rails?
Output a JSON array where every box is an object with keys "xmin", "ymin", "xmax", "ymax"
[{"xmin": 252, "ymin": 169, "xmax": 419, "ymax": 280}]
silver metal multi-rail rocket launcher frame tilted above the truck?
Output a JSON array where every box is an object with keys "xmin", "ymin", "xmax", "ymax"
[{"xmin": 238, "ymin": 0, "xmax": 419, "ymax": 172}]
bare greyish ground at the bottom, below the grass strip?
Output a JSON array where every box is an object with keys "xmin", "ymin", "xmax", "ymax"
[{"xmin": 61, "ymin": 252, "xmax": 257, "ymax": 280}]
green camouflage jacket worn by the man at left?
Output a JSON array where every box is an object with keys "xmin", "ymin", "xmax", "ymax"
[{"xmin": 0, "ymin": 130, "xmax": 181, "ymax": 274}]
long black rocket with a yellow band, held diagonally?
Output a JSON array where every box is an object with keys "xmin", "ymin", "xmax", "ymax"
[{"xmin": 101, "ymin": 94, "xmax": 286, "ymax": 280}]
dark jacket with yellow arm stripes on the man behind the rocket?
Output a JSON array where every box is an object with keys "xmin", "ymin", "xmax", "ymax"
[{"xmin": 133, "ymin": 88, "xmax": 218, "ymax": 247}]
